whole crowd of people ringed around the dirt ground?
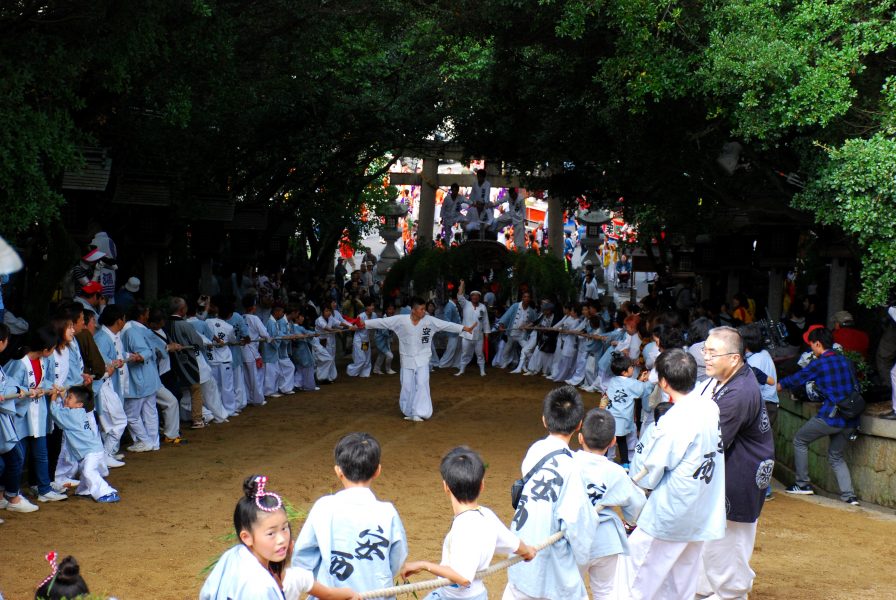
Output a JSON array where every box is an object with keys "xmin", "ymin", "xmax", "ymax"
[{"xmin": 0, "ymin": 227, "xmax": 880, "ymax": 598}]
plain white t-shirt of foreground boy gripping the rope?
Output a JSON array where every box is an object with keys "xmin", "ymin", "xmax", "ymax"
[{"xmin": 441, "ymin": 506, "xmax": 520, "ymax": 598}]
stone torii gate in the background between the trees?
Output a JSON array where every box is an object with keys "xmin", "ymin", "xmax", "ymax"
[{"xmin": 389, "ymin": 141, "xmax": 563, "ymax": 256}]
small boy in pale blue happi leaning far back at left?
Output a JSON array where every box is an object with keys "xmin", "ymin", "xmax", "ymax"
[{"xmin": 49, "ymin": 385, "xmax": 120, "ymax": 502}]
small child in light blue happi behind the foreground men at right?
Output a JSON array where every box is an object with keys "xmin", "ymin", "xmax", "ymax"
[{"xmin": 607, "ymin": 353, "xmax": 653, "ymax": 469}]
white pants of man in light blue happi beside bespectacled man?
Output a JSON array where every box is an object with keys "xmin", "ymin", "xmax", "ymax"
[{"xmin": 620, "ymin": 527, "xmax": 703, "ymax": 600}]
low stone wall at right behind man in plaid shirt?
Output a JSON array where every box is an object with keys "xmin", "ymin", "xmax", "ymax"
[{"xmin": 774, "ymin": 392, "xmax": 896, "ymax": 508}]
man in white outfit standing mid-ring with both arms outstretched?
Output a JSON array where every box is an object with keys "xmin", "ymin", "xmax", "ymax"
[{"xmin": 359, "ymin": 296, "xmax": 476, "ymax": 421}]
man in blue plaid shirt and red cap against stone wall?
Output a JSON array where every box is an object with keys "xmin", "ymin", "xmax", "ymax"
[{"xmin": 778, "ymin": 325, "xmax": 859, "ymax": 506}]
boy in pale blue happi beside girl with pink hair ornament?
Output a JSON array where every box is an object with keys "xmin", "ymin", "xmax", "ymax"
[{"xmin": 292, "ymin": 432, "xmax": 408, "ymax": 597}]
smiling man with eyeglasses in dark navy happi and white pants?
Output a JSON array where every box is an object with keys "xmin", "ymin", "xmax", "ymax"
[{"xmin": 697, "ymin": 327, "xmax": 775, "ymax": 600}]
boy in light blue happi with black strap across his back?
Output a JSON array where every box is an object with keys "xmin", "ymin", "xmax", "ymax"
[{"xmin": 504, "ymin": 386, "xmax": 598, "ymax": 600}]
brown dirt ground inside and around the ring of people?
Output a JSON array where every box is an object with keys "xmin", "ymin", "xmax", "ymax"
[{"xmin": 0, "ymin": 370, "xmax": 896, "ymax": 600}]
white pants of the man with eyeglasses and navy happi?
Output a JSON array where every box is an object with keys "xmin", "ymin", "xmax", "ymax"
[{"xmin": 697, "ymin": 521, "xmax": 756, "ymax": 600}]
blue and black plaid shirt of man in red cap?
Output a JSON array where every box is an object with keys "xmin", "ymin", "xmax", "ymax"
[{"xmin": 781, "ymin": 350, "xmax": 859, "ymax": 427}]
